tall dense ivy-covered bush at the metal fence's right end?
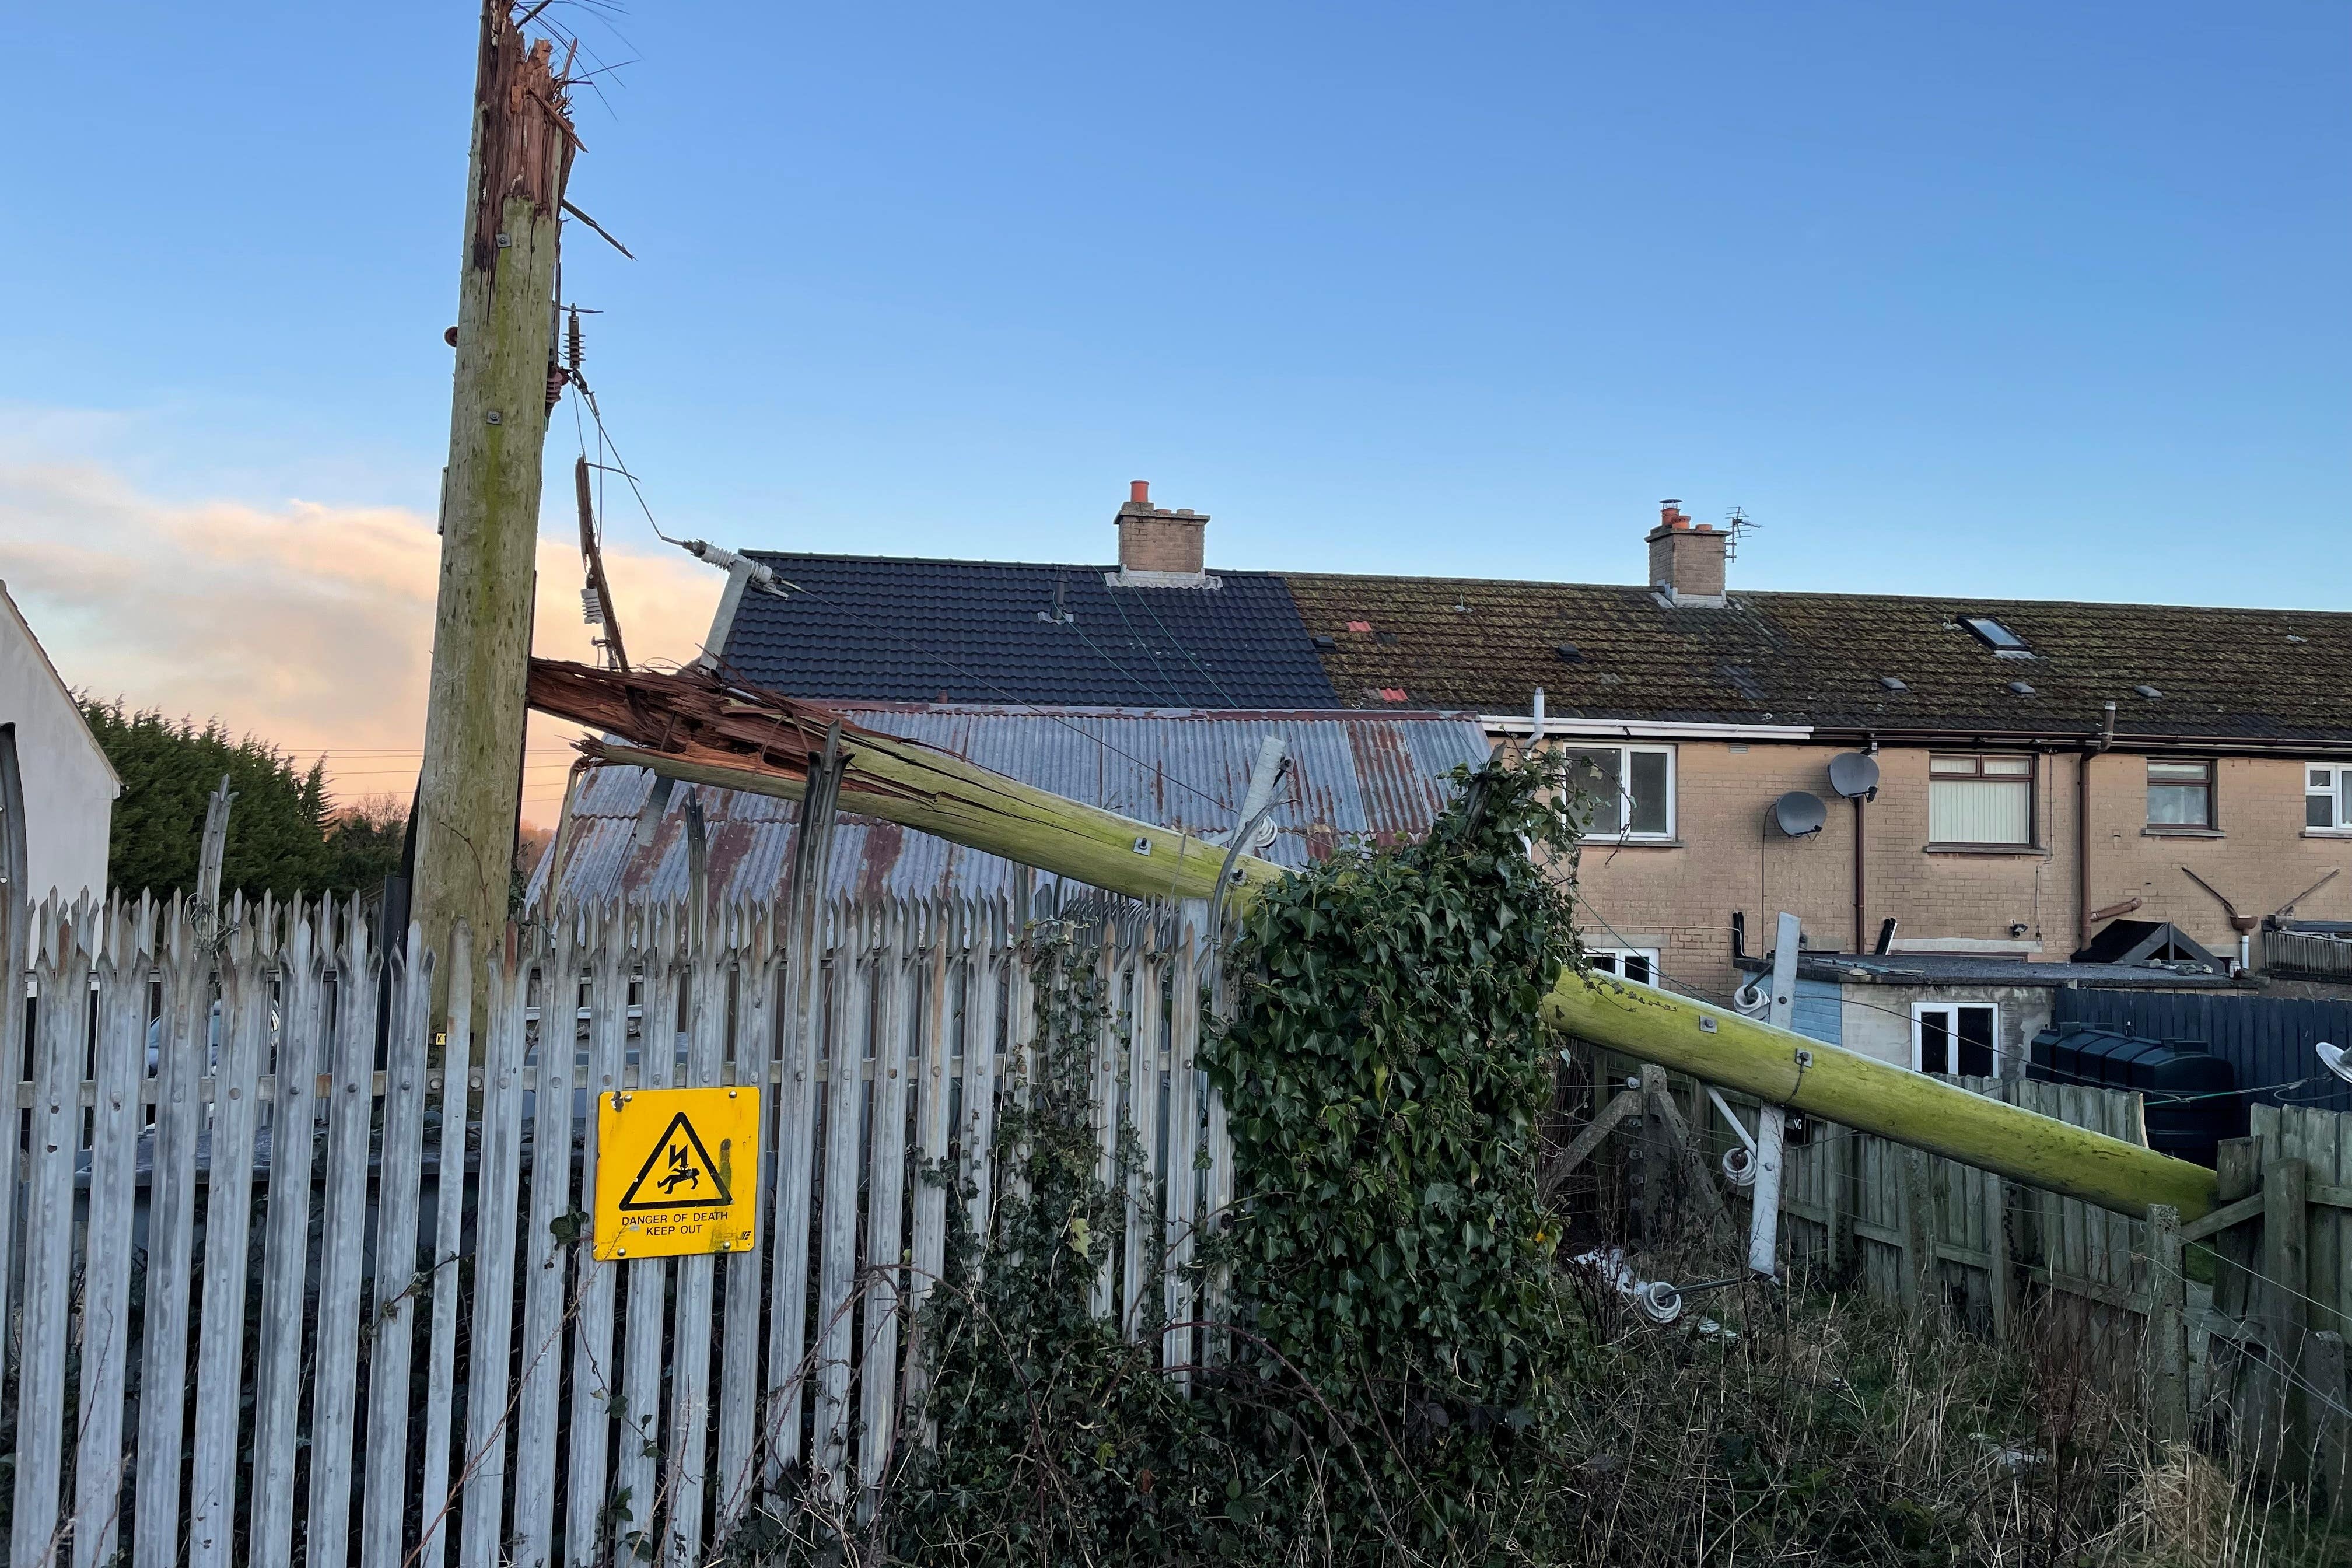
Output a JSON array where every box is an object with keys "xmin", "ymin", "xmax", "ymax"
[{"xmin": 1206, "ymin": 760, "xmax": 1576, "ymax": 1561}]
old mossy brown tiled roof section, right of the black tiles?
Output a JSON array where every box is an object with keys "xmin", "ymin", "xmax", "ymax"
[{"xmin": 1284, "ymin": 571, "xmax": 2352, "ymax": 740}]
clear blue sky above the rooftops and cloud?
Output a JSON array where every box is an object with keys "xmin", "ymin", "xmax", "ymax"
[{"xmin": 0, "ymin": 0, "xmax": 2352, "ymax": 630}]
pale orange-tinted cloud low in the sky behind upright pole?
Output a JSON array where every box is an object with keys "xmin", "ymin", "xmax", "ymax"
[{"xmin": 0, "ymin": 463, "xmax": 720, "ymax": 820}]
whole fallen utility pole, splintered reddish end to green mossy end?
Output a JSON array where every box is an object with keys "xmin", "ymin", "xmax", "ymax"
[{"xmin": 531, "ymin": 658, "xmax": 2216, "ymax": 1220}]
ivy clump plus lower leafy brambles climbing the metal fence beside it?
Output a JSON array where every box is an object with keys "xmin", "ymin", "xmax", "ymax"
[{"xmin": 870, "ymin": 760, "xmax": 1576, "ymax": 1566}]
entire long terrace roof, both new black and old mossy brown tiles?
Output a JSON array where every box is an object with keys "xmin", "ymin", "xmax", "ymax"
[{"xmin": 727, "ymin": 552, "xmax": 2352, "ymax": 743}]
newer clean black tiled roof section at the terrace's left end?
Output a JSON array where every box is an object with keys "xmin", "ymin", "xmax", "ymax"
[{"xmin": 727, "ymin": 550, "xmax": 1345, "ymax": 708}]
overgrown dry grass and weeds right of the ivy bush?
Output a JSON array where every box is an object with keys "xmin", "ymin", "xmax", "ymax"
[{"xmin": 1545, "ymin": 1276, "xmax": 2352, "ymax": 1568}]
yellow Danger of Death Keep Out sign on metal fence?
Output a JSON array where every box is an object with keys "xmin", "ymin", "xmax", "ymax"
[{"xmin": 595, "ymin": 1086, "xmax": 760, "ymax": 1262}]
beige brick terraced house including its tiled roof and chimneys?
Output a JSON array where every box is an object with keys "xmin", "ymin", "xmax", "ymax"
[{"xmin": 724, "ymin": 482, "xmax": 2352, "ymax": 995}]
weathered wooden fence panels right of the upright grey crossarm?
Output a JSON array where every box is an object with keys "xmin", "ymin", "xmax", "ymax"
[{"xmin": 1783, "ymin": 1079, "xmax": 2352, "ymax": 1514}]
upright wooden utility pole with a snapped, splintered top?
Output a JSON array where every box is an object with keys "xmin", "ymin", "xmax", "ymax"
[{"xmin": 414, "ymin": 0, "xmax": 579, "ymax": 1011}]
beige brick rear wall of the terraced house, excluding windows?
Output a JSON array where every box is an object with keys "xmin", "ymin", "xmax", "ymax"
[{"xmin": 1542, "ymin": 740, "xmax": 2352, "ymax": 992}]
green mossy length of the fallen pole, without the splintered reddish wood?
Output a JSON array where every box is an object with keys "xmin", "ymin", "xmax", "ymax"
[{"xmin": 569, "ymin": 733, "xmax": 2216, "ymax": 1220}]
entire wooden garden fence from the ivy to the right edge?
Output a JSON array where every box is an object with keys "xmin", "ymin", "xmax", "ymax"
[{"xmin": 1545, "ymin": 1051, "xmax": 2352, "ymax": 1518}]
